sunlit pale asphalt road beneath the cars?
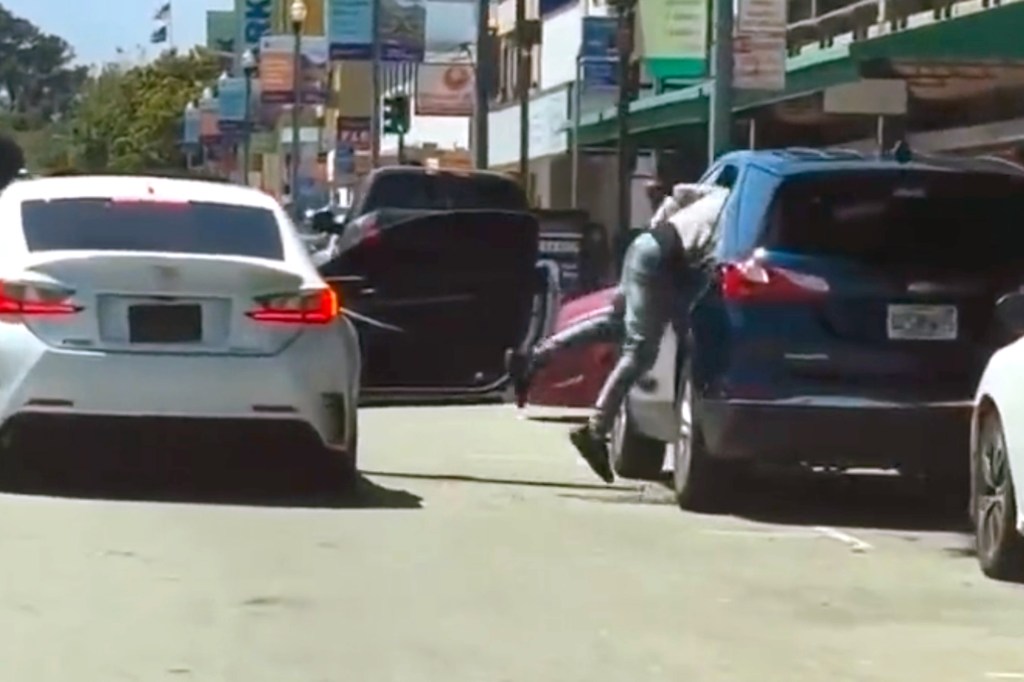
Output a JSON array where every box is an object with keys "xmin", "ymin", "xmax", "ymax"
[{"xmin": 0, "ymin": 407, "xmax": 1024, "ymax": 682}]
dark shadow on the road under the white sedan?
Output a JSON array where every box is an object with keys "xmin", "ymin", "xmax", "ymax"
[{"xmin": 0, "ymin": 451, "xmax": 423, "ymax": 509}]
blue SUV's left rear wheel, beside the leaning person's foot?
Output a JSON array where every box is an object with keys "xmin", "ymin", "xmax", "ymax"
[{"xmin": 672, "ymin": 366, "xmax": 738, "ymax": 512}]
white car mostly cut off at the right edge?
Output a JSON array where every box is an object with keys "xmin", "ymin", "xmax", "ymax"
[{"xmin": 971, "ymin": 290, "xmax": 1024, "ymax": 581}]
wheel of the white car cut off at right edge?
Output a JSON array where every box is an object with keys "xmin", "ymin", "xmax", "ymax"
[{"xmin": 971, "ymin": 410, "xmax": 1024, "ymax": 582}]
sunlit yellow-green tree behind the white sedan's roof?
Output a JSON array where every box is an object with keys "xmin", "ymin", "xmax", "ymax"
[{"xmin": 71, "ymin": 49, "xmax": 220, "ymax": 172}]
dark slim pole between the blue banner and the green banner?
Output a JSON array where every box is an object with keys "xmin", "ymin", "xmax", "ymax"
[{"xmin": 614, "ymin": 0, "xmax": 634, "ymax": 241}]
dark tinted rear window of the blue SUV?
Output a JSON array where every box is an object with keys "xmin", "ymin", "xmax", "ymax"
[{"xmin": 765, "ymin": 171, "xmax": 1024, "ymax": 269}]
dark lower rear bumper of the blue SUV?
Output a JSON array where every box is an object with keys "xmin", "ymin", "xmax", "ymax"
[{"xmin": 700, "ymin": 398, "xmax": 973, "ymax": 472}]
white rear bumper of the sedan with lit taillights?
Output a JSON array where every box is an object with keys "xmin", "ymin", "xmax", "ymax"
[{"xmin": 0, "ymin": 329, "xmax": 358, "ymax": 447}]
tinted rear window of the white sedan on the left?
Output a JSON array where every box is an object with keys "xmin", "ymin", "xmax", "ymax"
[{"xmin": 22, "ymin": 199, "xmax": 284, "ymax": 260}]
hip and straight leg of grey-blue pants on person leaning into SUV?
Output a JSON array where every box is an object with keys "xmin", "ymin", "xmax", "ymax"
[{"xmin": 590, "ymin": 233, "xmax": 675, "ymax": 436}]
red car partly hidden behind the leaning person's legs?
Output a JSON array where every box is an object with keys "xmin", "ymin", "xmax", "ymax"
[{"xmin": 528, "ymin": 287, "xmax": 617, "ymax": 408}]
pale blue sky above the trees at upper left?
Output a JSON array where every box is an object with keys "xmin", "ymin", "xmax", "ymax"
[{"xmin": 2, "ymin": 0, "xmax": 233, "ymax": 63}]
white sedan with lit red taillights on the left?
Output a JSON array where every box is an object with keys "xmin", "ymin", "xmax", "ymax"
[{"xmin": 0, "ymin": 176, "xmax": 359, "ymax": 476}]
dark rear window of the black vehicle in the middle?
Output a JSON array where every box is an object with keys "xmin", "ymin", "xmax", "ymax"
[{"xmin": 365, "ymin": 172, "xmax": 528, "ymax": 212}]
